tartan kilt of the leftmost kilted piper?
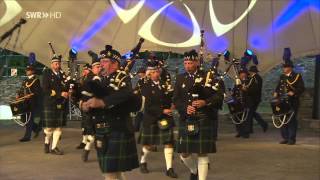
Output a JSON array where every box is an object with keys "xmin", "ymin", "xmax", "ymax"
[{"xmin": 43, "ymin": 101, "xmax": 67, "ymax": 128}]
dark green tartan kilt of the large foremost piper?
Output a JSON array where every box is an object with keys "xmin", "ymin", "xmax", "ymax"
[{"xmin": 95, "ymin": 129, "xmax": 139, "ymax": 173}]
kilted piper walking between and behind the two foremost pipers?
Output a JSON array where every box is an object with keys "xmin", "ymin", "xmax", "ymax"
[{"xmin": 138, "ymin": 61, "xmax": 178, "ymax": 178}]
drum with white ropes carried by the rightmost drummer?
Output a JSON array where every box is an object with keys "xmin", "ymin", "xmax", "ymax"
[{"xmin": 270, "ymin": 93, "xmax": 295, "ymax": 128}]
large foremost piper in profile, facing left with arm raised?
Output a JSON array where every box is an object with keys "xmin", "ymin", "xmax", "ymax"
[{"xmin": 82, "ymin": 46, "xmax": 139, "ymax": 179}]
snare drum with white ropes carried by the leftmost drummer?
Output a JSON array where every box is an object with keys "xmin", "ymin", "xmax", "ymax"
[{"xmin": 10, "ymin": 93, "xmax": 34, "ymax": 126}]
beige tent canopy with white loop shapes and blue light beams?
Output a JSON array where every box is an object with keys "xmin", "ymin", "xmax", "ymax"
[{"xmin": 0, "ymin": 0, "xmax": 320, "ymax": 72}]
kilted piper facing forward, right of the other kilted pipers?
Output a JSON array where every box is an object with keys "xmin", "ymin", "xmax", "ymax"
[{"xmin": 173, "ymin": 50, "xmax": 223, "ymax": 180}]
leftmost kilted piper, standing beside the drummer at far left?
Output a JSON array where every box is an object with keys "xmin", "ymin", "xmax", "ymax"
[{"xmin": 42, "ymin": 55, "xmax": 68, "ymax": 155}]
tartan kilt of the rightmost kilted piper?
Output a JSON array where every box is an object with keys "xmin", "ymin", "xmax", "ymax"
[{"xmin": 176, "ymin": 114, "xmax": 217, "ymax": 154}]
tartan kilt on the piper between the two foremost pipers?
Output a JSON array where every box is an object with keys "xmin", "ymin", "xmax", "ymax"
[{"xmin": 138, "ymin": 124, "xmax": 174, "ymax": 145}]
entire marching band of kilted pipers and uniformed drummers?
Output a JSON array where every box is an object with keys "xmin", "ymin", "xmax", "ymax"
[{"xmin": 11, "ymin": 34, "xmax": 304, "ymax": 180}]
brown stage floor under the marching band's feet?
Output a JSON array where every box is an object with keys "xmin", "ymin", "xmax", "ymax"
[{"xmin": 0, "ymin": 119, "xmax": 320, "ymax": 180}]
